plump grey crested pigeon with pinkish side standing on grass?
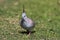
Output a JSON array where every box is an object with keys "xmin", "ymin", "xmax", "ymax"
[{"xmin": 20, "ymin": 5, "xmax": 35, "ymax": 35}]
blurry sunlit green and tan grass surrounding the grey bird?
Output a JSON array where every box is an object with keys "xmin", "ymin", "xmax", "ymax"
[{"xmin": 0, "ymin": 0, "xmax": 60, "ymax": 40}]
